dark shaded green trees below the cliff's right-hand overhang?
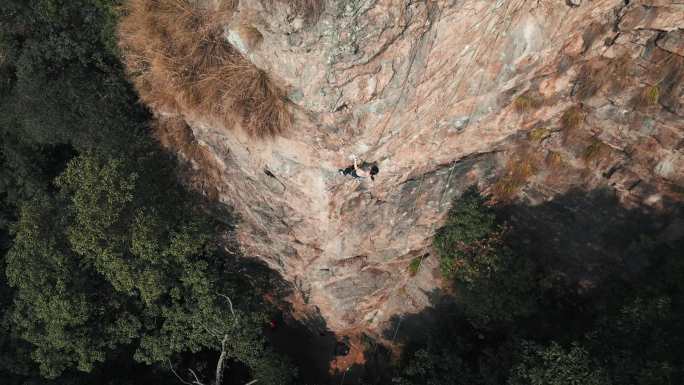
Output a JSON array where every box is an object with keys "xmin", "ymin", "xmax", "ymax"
[{"xmin": 404, "ymin": 190, "xmax": 684, "ymax": 385}]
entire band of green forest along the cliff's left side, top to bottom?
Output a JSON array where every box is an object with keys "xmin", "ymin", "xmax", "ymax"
[{"xmin": 0, "ymin": 0, "xmax": 293, "ymax": 384}]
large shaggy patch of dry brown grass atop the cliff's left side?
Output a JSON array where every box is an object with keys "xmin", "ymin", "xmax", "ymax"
[{"xmin": 119, "ymin": 0, "xmax": 291, "ymax": 137}]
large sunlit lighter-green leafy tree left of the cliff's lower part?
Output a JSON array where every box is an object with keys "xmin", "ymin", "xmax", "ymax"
[{"xmin": 7, "ymin": 154, "xmax": 290, "ymax": 383}]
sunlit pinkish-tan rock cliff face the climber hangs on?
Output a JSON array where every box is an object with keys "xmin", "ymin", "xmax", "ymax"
[{"xmin": 150, "ymin": 0, "xmax": 684, "ymax": 332}]
